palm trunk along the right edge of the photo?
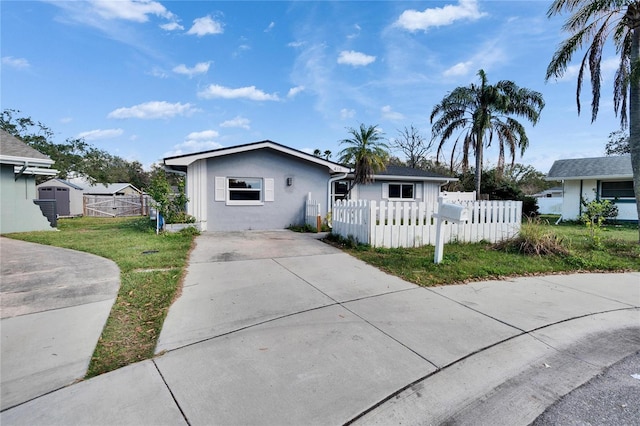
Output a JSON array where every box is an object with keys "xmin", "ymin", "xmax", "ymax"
[{"xmin": 629, "ymin": 28, "xmax": 640, "ymax": 244}]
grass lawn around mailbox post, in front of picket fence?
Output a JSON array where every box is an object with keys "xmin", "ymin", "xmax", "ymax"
[{"xmin": 341, "ymin": 222, "xmax": 640, "ymax": 286}]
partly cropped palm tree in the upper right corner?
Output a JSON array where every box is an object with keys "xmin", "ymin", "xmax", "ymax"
[{"xmin": 546, "ymin": 0, "xmax": 640, "ymax": 241}]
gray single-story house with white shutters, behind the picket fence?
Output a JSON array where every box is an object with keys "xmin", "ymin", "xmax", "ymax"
[{"xmin": 164, "ymin": 140, "xmax": 455, "ymax": 231}]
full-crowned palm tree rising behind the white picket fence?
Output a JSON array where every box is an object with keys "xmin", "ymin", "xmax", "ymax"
[{"xmin": 430, "ymin": 70, "xmax": 544, "ymax": 197}]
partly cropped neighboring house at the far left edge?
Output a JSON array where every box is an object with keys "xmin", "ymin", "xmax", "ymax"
[{"xmin": 0, "ymin": 130, "xmax": 58, "ymax": 234}]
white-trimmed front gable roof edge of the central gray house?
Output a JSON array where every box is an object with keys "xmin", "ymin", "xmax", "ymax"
[{"xmin": 164, "ymin": 140, "xmax": 350, "ymax": 173}]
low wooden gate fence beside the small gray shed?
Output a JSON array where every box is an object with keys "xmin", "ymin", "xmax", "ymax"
[{"xmin": 83, "ymin": 195, "xmax": 151, "ymax": 217}]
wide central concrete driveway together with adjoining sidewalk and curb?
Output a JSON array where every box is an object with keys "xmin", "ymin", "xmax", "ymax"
[{"xmin": 0, "ymin": 231, "xmax": 640, "ymax": 425}]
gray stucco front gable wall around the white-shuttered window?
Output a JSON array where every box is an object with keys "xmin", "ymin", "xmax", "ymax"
[{"xmin": 207, "ymin": 149, "xmax": 329, "ymax": 231}]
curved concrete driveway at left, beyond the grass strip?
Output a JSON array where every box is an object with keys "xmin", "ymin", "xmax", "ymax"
[{"xmin": 0, "ymin": 238, "xmax": 120, "ymax": 410}]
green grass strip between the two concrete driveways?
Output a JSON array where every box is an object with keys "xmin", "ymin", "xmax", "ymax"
[{"xmin": 6, "ymin": 217, "xmax": 194, "ymax": 378}]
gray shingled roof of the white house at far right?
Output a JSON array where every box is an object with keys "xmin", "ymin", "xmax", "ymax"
[{"xmin": 546, "ymin": 155, "xmax": 633, "ymax": 180}]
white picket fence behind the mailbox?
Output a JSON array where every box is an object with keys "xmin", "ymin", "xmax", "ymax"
[{"xmin": 332, "ymin": 200, "xmax": 522, "ymax": 248}]
